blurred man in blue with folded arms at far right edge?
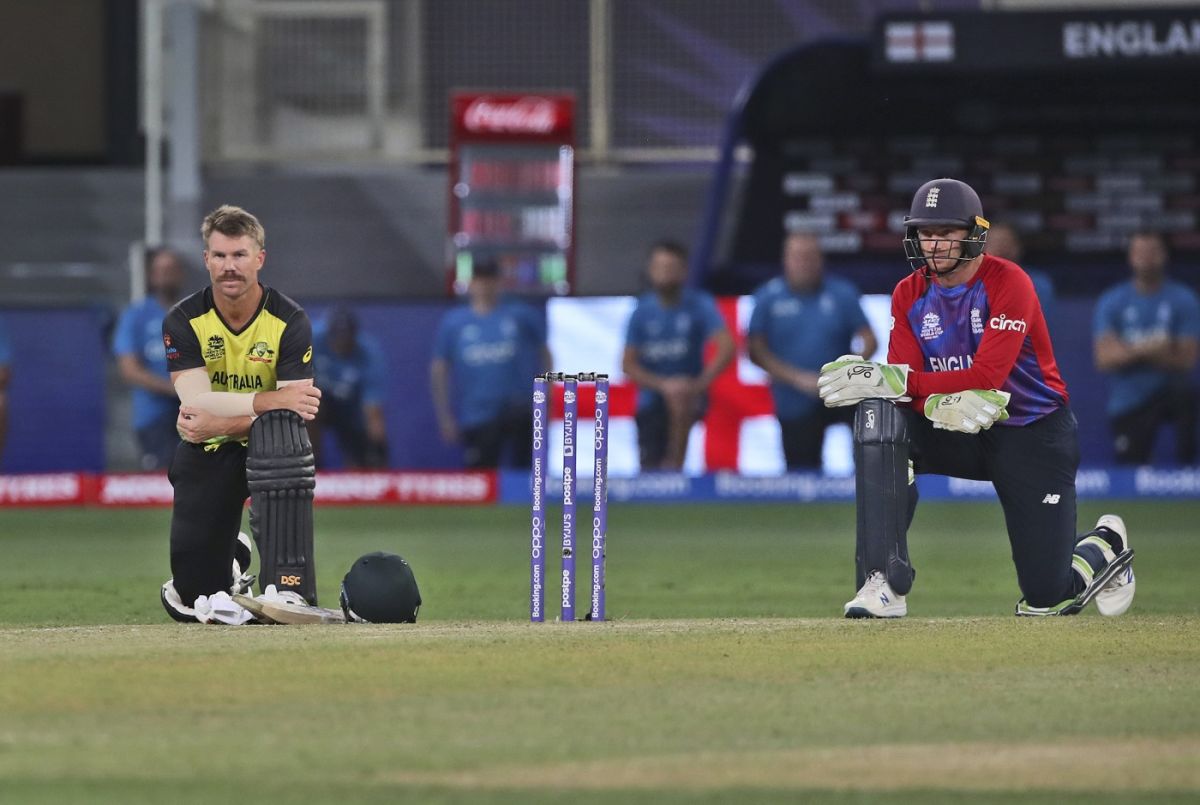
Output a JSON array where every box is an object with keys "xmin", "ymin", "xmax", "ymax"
[{"xmin": 1093, "ymin": 232, "xmax": 1200, "ymax": 464}]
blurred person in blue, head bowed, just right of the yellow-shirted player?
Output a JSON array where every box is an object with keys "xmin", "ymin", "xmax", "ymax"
[{"xmin": 312, "ymin": 306, "xmax": 388, "ymax": 469}]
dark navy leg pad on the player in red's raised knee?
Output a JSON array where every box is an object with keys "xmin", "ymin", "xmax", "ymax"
[{"xmin": 854, "ymin": 400, "xmax": 916, "ymax": 595}]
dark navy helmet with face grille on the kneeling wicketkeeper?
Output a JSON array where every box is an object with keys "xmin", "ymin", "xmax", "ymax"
[{"xmin": 904, "ymin": 179, "xmax": 990, "ymax": 276}]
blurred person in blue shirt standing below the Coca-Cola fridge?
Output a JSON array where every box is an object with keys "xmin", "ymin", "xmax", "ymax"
[{"xmin": 430, "ymin": 260, "xmax": 551, "ymax": 469}]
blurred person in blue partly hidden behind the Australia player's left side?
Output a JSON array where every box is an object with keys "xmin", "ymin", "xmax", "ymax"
[{"xmin": 113, "ymin": 248, "xmax": 184, "ymax": 470}]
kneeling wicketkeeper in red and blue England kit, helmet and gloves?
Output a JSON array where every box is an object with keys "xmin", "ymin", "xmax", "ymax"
[{"xmin": 818, "ymin": 179, "xmax": 1135, "ymax": 618}]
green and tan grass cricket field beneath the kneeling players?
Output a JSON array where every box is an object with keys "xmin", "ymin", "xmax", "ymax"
[{"xmin": 0, "ymin": 503, "xmax": 1200, "ymax": 805}]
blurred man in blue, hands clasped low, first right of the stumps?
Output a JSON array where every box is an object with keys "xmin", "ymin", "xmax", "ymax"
[{"xmin": 622, "ymin": 241, "xmax": 733, "ymax": 470}]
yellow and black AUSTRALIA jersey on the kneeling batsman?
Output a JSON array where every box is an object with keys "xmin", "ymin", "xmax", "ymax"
[{"xmin": 162, "ymin": 286, "xmax": 312, "ymax": 443}]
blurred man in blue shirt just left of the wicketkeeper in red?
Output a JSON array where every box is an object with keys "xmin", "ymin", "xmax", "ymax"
[{"xmin": 748, "ymin": 233, "xmax": 877, "ymax": 469}]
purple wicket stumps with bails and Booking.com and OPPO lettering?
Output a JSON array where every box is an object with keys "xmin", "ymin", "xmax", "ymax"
[{"xmin": 529, "ymin": 372, "xmax": 608, "ymax": 621}]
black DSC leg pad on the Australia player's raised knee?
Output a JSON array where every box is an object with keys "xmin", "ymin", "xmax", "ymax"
[{"xmin": 246, "ymin": 410, "xmax": 317, "ymax": 605}]
